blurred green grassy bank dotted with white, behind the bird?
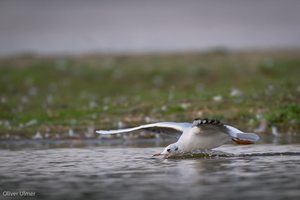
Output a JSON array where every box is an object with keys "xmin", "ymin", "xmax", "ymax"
[{"xmin": 0, "ymin": 50, "xmax": 300, "ymax": 137}]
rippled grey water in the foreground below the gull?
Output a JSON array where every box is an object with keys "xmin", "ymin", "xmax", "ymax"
[{"xmin": 0, "ymin": 141, "xmax": 300, "ymax": 200}]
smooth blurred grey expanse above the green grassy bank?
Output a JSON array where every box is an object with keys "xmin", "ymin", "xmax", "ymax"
[{"xmin": 0, "ymin": 0, "xmax": 300, "ymax": 55}]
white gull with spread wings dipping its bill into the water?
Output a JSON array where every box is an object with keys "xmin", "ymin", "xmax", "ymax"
[{"xmin": 96, "ymin": 119, "xmax": 259, "ymax": 156}]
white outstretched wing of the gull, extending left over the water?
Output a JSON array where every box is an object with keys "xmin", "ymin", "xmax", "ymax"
[{"xmin": 96, "ymin": 122, "xmax": 191, "ymax": 134}]
